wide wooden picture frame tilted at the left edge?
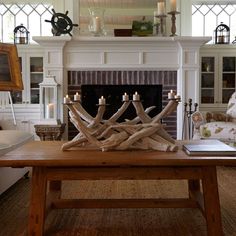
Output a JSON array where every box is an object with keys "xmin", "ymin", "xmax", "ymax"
[{"xmin": 0, "ymin": 43, "xmax": 23, "ymax": 91}]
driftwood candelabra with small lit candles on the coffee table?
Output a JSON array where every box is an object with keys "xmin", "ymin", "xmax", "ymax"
[{"xmin": 62, "ymin": 92, "xmax": 180, "ymax": 151}]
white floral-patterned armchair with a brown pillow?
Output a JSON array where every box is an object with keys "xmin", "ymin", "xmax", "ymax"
[{"xmin": 192, "ymin": 92, "xmax": 236, "ymax": 142}]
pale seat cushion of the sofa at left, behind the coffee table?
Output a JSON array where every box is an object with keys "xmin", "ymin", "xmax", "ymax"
[{"xmin": 0, "ymin": 130, "xmax": 33, "ymax": 156}]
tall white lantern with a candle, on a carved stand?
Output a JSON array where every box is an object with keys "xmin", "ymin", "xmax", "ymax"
[{"xmin": 39, "ymin": 76, "xmax": 59, "ymax": 124}]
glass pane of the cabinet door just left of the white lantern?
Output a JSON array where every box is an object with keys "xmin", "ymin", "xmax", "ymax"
[{"xmin": 30, "ymin": 57, "xmax": 43, "ymax": 104}]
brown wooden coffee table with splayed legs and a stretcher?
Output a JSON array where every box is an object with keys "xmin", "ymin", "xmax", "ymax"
[{"xmin": 0, "ymin": 141, "xmax": 236, "ymax": 236}]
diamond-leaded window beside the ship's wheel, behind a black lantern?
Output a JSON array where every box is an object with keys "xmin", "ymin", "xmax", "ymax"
[{"xmin": 0, "ymin": 3, "xmax": 52, "ymax": 42}]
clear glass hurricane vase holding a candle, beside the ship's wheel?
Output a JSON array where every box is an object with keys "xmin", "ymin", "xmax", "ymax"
[{"xmin": 88, "ymin": 8, "xmax": 105, "ymax": 36}]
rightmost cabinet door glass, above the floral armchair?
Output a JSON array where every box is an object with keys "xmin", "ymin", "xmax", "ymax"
[{"xmin": 222, "ymin": 57, "xmax": 236, "ymax": 103}]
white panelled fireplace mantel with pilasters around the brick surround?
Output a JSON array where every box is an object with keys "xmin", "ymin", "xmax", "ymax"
[{"xmin": 33, "ymin": 36, "xmax": 211, "ymax": 139}]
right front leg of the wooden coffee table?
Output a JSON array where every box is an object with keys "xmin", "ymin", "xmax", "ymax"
[{"xmin": 202, "ymin": 166, "xmax": 223, "ymax": 236}]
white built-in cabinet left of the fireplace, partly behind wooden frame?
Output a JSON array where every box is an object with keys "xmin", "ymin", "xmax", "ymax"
[{"xmin": 0, "ymin": 45, "xmax": 44, "ymax": 139}]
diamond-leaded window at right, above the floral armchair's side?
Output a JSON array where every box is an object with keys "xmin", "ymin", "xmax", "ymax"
[{"xmin": 192, "ymin": 4, "xmax": 236, "ymax": 42}]
